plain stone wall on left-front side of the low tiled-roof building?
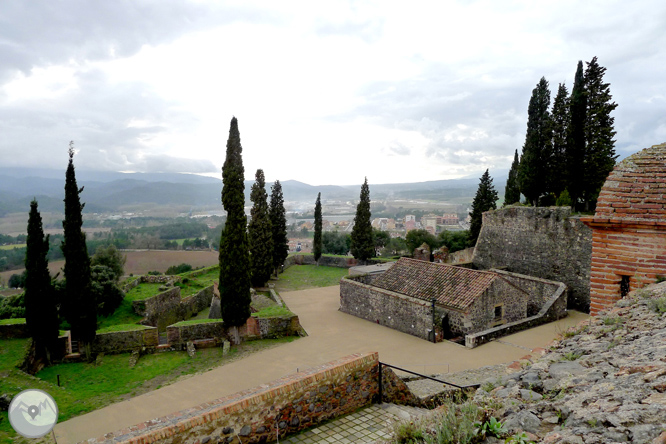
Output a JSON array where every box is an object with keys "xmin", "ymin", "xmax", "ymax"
[{"xmin": 340, "ymin": 276, "xmax": 433, "ymax": 340}]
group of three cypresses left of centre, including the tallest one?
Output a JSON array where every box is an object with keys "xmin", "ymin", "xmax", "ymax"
[{"xmin": 219, "ymin": 117, "xmax": 289, "ymax": 343}]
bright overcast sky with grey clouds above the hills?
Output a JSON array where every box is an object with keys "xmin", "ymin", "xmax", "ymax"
[{"xmin": 0, "ymin": 0, "xmax": 666, "ymax": 186}]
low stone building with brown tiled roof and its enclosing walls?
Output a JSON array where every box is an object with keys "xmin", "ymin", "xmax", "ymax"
[{"xmin": 340, "ymin": 258, "xmax": 566, "ymax": 345}]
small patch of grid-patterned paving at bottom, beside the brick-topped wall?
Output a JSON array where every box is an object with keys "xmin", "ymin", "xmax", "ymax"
[{"xmin": 280, "ymin": 404, "xmax": 423, "ymax": 444}]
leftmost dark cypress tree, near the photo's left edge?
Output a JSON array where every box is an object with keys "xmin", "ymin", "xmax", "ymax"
[{"xmin": 24, "ymin": 199, "xmax": 58, "ymax": 362}]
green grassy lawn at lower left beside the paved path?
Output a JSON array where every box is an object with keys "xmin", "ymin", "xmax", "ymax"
[{"xmin": 0, "ymin": 337, "xmax": 297, "ymax": 444}]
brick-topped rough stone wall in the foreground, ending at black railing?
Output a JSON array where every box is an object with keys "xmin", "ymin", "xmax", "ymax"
[{"xmin": 88, "ymin": 353, "xmax": 413, "ymax": 444}]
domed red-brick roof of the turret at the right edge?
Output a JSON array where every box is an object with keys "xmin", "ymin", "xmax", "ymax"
[{"xmin": 594, "ymin": 143, "xmax": 666, "ymax": 222}]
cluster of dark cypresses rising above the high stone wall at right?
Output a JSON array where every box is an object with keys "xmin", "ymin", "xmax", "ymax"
[{"xmin": 504, "ymin": 57, "xmax": 618, "ymax": 211}]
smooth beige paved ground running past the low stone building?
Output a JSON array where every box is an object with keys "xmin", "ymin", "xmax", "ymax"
[{"xmin": 54, "ymin": 286, "xmax": 587, "ymax": 444}]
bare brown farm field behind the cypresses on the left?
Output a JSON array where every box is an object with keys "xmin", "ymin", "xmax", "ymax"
[{"xmin": 0, "ymin": 250, "xmax": 218, "ymax": 283}]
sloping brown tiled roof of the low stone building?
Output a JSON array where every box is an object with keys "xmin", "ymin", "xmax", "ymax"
[{"xmin": 372, "ymin": 257, "xmax": 498, "ymax": 310}]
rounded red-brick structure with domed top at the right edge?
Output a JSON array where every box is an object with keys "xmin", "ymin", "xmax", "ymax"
[{"xmin": 581, "ymin": 143, "xmax": 666, "ymax": 315}]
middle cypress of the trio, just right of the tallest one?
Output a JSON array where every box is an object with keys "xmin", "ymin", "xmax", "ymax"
[{"xmin": 248, "ymin": 169, "xmax": 273, "ymax": 287}]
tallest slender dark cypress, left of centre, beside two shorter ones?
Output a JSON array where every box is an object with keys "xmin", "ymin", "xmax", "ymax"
[{"xmin": 219, "ymin": 117, "xmax": 252, "ymax": 343}]
